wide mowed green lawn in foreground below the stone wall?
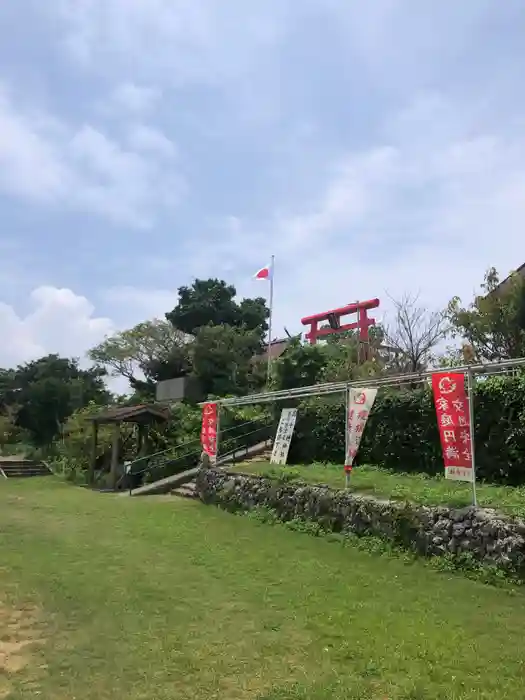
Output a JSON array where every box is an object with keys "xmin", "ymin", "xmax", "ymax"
[{"xmin": 0, "ymin": 477, "xmax": 525, "ymax": 700}]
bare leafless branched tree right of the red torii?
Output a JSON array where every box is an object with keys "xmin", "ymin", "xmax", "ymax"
[{"xmin": 378, "ymin": 294, "xmax": 448, "ymax": 372}]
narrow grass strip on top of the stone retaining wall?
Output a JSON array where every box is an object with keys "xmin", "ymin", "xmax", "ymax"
[{"xmin": 235, "ymin": 461, "xmax": 525, "ymax": 518}]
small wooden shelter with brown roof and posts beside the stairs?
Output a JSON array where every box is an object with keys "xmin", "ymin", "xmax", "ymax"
[{"xmin": 89, "ymin": 404, "xmax": 169, "ymax": 488}]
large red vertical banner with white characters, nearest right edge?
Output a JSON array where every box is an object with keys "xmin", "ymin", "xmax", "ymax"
[{"xmin": 432, "ymin": 372, "xmax": 474, "ymax": 482}]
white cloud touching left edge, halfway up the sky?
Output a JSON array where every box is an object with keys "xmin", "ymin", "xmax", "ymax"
[{"xmin": 0, "ymin": 85, "xmax": 184, "ymax": 226}]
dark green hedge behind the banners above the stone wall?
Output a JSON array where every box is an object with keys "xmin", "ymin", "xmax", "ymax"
[{"xmin": 289, "ymin": 375, "xmax": 525, "ymax": 486}]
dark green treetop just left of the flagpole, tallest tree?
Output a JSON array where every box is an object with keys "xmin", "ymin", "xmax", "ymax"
[{"xmin": 166, "ymin": 279, "xmax": 269, "ymax": 339}]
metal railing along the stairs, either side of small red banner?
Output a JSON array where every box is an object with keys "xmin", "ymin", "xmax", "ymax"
[{"xmin": 116, "ymin": 421, "xmax": 274, "ymax": 492}]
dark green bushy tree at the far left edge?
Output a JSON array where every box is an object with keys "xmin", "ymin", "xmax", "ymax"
[{"xmin": 0, "ymin": 355, "xmax": 111, "ymax": 445}]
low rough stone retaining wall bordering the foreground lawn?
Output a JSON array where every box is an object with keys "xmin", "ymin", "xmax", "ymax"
[{"xmin": 197, "ymin": 469, "xmax": 525, "ymax": 578}]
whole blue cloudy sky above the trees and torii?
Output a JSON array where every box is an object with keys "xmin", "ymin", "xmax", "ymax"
[{"xmin": 0, "ymin": 0, "xmax": 525, "ymax": 366}]
